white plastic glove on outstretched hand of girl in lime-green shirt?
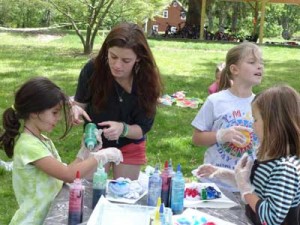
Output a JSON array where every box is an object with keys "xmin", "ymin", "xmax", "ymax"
[{"xmin": 90, "ymin": 147, "xmax": 123, "ymax": 165}]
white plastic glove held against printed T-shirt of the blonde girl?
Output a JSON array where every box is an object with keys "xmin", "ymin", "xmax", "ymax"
[{"xmin": 216, "ymin": 126, "xmax": 252, "ymax": 145}]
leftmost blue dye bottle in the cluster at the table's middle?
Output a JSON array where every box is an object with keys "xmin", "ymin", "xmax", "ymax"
[{"xmin": 147, "ymin": 165, "xmax": 162, "ymax": 206}]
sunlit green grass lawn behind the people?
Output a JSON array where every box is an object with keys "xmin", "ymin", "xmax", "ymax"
[{"xmin": 0, "ymin": 30, "xmax": 300, "ymax": 224}]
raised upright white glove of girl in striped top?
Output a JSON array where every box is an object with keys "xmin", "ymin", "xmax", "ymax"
[{"xmin": 234, "ymin": 153, "xmax": 254, "ymax": 202}]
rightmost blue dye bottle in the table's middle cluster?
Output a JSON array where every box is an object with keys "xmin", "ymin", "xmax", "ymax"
[{"xmin": 171, "ymin": 164, "xmax": 185, "ymax": 215}]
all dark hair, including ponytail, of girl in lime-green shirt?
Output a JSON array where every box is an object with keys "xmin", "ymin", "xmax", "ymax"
[{"xmin": 0, "ymin": 77, "xmax": 72, "ymax": 158}]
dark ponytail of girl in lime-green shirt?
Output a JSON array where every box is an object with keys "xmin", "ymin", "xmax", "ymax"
[{"xmin": 0, "ymin": 106, "xmax": 21, "ymax": 158}]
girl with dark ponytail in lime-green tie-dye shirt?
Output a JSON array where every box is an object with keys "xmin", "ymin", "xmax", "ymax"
[{"xmin": 0, "ymin": 77, "xmax": 122, "ymax": 225}]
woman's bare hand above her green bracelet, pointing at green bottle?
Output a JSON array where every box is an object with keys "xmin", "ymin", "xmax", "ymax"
[{"xmin": 98, "ymin": 121, "xmax": 124, "ymax": 141}]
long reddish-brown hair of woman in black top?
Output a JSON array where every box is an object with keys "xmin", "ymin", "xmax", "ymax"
[{"xmin": 91, "ymin": 23, "xmax": 162, "ymax": 116}]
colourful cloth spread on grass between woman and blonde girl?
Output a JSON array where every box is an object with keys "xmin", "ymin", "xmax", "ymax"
[{"xmin": 159, "ymin": 91, "xmax": 203, "ymax": 109}]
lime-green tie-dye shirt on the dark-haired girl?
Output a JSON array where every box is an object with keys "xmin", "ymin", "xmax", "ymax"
[{"xmin": 10, "ymin": 133, "xmax": 63, "ymax": 225}]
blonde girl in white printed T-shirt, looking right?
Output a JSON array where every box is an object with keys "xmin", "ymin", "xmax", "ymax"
[{"xmin": 192, "ymin": 42, "xmax": 263, "ymax": 191}]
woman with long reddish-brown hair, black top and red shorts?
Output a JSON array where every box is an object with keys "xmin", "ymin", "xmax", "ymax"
[{"xmin": 72, "ymin": 23, "xmax": 162, "ymax": 180}]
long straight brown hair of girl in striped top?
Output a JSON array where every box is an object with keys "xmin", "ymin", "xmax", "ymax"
[{"xmin": 252, "ymin": 85, "xmax": 300, "ymax": 160}]
